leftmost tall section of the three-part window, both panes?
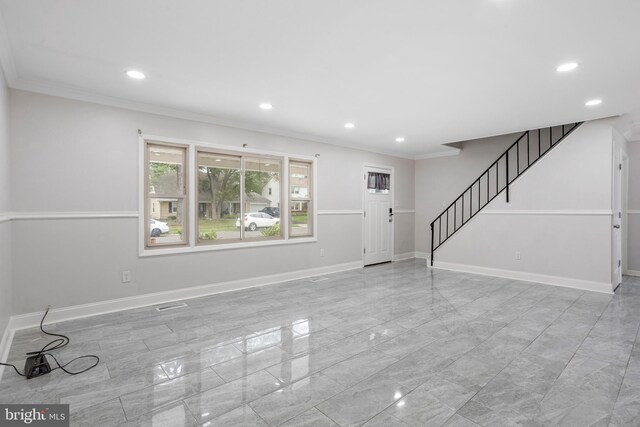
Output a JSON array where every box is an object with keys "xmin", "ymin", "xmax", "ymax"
[{"xmin": 145, "ymin": 143, "xmax": 188, "ymax": 247}]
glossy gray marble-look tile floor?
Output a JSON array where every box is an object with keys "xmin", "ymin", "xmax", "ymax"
[{"xmin": 0, "ymin": 260, "xmax": 640, "ymax": 427}]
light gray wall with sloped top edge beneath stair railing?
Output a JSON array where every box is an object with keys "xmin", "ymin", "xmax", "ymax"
[{"xmin": 416, "ymin": 120, "xmax": 612, "ymax": 292}]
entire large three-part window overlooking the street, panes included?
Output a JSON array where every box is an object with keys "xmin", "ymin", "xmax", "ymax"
[{"xmin": 140, "ymin": 138, "xmax": 314, "ymax": 255}]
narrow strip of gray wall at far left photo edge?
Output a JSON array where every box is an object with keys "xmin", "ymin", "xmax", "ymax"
[{"xmin": 0, "ymin": 67, "xmax": 12, "ymax": 338}]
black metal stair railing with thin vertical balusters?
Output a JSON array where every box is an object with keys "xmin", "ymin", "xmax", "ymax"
[{"xmin": 431, "ymin": 122, "xmax": 582, "ymax": 266}]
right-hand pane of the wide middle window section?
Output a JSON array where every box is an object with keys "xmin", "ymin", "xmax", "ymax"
[{"xmin": 244, "ymin": 157, "xmax": 282, "ymax": 240}]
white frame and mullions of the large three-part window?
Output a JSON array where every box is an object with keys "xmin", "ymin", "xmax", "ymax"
[{"xmin": 138, "ymin": 134, "xmax": 318, "ymax": 257}]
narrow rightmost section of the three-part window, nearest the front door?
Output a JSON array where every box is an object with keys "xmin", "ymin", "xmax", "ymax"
[{"xmin": 289, "ymin": 160, "xmax": 313, "ymax": 237}]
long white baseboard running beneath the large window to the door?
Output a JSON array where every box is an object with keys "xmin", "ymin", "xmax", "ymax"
[{"xmin": 10, "ymin": 261, "xmax": 362, "ymax": 331}]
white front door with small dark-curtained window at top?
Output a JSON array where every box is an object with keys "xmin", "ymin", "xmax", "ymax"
[{"xmin": 364, "ymin": 166, "xmax": 393, "ymax": 265}]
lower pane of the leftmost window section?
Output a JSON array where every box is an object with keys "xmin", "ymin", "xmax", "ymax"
[{"xmin": 147, "ymin": 197, "xmax": 187, "ymax": 246}]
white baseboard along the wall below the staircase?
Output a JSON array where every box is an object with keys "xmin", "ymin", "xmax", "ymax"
[{"xmin": 433, "ymin": 260, "xmax": 613, "ymax": 294}]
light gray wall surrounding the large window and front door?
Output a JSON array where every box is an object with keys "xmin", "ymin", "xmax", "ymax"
[{"xmin": 11, "ymin": 91, "xmax": 414, "ymax": 314}]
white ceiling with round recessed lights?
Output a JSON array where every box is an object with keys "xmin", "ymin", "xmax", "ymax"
[{"xmin": 0, "ymin": 0, "xmax": 640, "ymax": 158}]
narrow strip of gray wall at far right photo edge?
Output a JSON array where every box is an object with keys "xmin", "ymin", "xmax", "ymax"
[{"xmin": 627, "ymin": 142, "xmax": 640, "ymax": 272}]
